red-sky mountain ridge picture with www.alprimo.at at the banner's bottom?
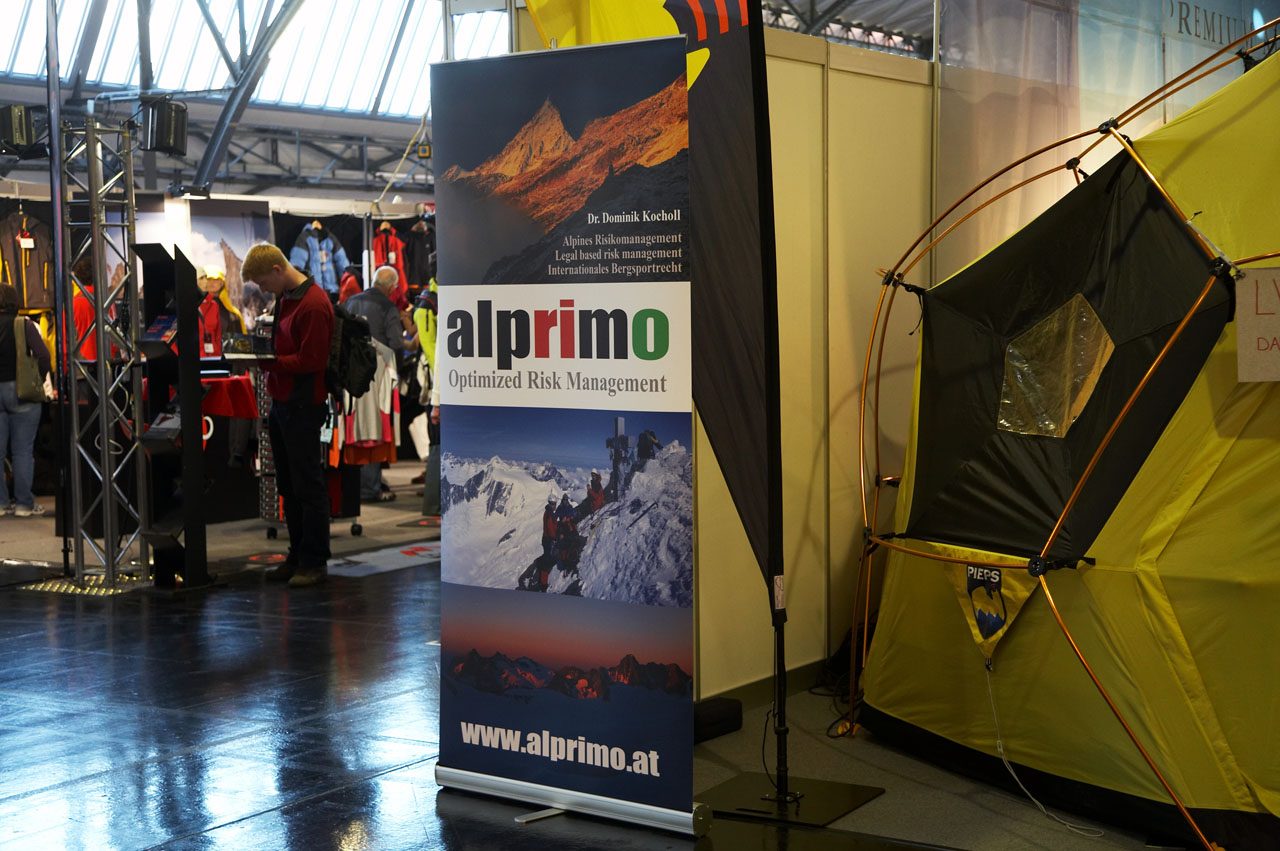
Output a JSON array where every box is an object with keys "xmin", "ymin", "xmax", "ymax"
[{"xmin": 440, "ymin": 582, "xmax": 694, "ymax": 810}]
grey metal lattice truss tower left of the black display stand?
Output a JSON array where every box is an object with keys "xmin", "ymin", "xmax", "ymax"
[{"xmin": 59, "ymin": 115, "xmax": 150, "ymax": 590}]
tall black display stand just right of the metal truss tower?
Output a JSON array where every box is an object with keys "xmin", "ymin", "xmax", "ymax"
[{"xmin": 134, "ymin": 243, "xmax": 210, "ymax": 590}]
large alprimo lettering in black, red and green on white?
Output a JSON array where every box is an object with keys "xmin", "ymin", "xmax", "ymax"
[{"xmin": 444, "ymin": 298, "xmax": 671, "ymax": 370}]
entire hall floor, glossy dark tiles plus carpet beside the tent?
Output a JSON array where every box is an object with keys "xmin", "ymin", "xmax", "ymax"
[{"xmin": 0, "ymin": 460, "xmax": 1143, "ymax": 851}]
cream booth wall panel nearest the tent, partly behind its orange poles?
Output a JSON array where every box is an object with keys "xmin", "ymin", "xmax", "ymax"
[{"xmin": 827, "ymin": 53, "xmax": 933, "ymax": 646}]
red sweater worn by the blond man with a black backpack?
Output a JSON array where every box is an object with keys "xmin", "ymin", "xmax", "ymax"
[{"xmin": 264, "ymin": 278, "xmax": 333, "ymax": 403}]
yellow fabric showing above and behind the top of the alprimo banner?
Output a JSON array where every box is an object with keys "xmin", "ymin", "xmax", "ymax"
[{"xmin": 529, "ymin": 0, "xmax": 710, "ymax": 88}]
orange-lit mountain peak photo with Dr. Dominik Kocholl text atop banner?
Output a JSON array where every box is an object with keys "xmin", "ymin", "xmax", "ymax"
[{"xmin": 433, "ymin": 40, "xmax": 690, "ymax": 284}]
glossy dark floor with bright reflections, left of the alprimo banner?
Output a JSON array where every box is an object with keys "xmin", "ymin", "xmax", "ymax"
[{"xmin": 0, "ymin": 566, "xmax": 439, "ymax": 850}]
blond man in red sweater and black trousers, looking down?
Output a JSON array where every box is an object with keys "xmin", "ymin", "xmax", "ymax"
[{"xmin": 241, "ymin": 243, "xmax": 334, "ymax": 587}]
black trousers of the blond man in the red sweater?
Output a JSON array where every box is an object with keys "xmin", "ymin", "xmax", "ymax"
[{"xmin": 269, "ymin": 402, "xmax": 329, "ymax": 569}]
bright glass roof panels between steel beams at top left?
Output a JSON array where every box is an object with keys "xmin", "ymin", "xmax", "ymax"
[{"xmin": 0, "ymin": 0, "xmax": 483, "ymax": 116}]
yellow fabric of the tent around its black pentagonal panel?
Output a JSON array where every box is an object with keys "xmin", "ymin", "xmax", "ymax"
[{"xmin": 864, "ymin": 58, "xmax": 1280, "ymax": 815}]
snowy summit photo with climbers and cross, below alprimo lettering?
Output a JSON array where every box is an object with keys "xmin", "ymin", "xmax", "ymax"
[{"xmin": 440, "ymin": 406, "xmax": 694, "ymax": 608}]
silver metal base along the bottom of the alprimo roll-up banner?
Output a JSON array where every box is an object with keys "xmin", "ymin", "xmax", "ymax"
[{"xmin": 435, "ymin": 764, "xmax": 712, "ymax": 837}]
